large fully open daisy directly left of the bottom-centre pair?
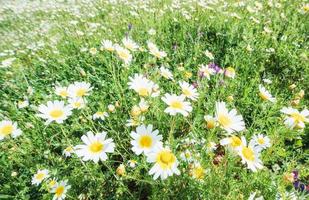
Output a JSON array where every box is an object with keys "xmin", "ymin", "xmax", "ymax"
[{"xmin": 74, "ymin": 131, "xmax": 115, "ymax": 163}]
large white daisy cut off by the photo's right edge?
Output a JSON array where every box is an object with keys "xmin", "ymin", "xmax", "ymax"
[{"xmin": 280, "ymin": 107, "xmax": 309, "ymax": 129}]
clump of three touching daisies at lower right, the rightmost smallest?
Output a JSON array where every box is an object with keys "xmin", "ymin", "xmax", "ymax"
[{"xmin": 220, "ymin": 134, "xmax": 271, "ymax": 172}]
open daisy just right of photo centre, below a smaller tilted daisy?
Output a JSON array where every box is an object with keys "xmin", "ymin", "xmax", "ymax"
[{"xmin": 162, "ymin": 93, "xmax": 192, "ymax": 117}]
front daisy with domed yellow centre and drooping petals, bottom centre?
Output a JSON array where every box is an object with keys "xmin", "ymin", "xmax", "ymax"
[{"xmin": 147, "ymin": 145, "xmax": 180, "ymax": 180}]
